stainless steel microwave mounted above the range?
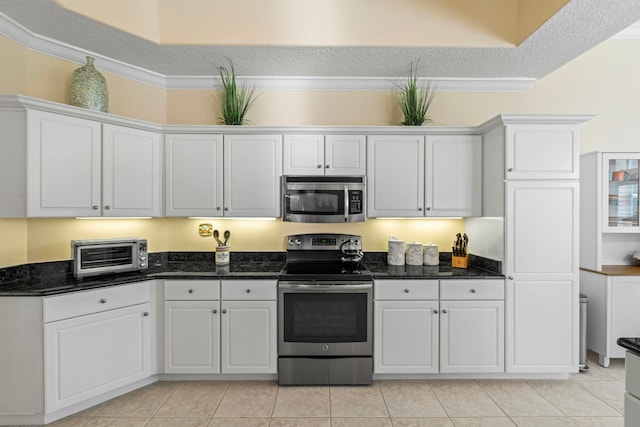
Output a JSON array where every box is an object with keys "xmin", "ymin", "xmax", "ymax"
[{"xmin": 282, "ymin": 176, "xmax": 366, "ymax": 223}]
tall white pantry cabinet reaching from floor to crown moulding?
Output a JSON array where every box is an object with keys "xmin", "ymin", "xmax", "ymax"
[{"xmin": 483, "ymin": 115, "xmax": 589, "ymax": 373}]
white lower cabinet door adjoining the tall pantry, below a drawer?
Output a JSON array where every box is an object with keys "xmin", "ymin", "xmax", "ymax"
[{"xmin": 440, "ymin": 301, "xmax": 504, "ymax": 373}]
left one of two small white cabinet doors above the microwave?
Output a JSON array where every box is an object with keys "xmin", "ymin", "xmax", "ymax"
[{"xmin": 283, "ymin": 135, "xmax": 325, "ymax": 175}]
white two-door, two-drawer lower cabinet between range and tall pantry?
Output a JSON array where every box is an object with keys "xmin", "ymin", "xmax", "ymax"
[{"xmin": 374, "ymin": 280, "xmax": 505, "ymax": 374}]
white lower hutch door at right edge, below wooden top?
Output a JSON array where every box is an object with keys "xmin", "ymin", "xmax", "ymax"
[{"xmin": 607, "ymin": 276, "xmax": 640, "ymax": 357}]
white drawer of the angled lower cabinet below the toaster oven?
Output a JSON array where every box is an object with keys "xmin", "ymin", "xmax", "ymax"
[{"xmin": 43, "ymin": 282, "xmax": 151, "ymax": 323}]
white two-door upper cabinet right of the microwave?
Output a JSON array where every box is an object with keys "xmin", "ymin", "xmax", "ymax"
[{"xmin": 367, "ymin": 135, "xmax": 482, "ymax": 217}]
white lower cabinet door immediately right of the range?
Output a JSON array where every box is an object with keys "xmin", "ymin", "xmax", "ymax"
[{"xmin": 373, "ymin": 301, "xmax": 438, "ymax": 374}]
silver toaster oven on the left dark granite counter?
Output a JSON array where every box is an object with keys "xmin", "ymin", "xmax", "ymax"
[{"xmin": 71, "ymin": 237, "xmax": 149, "ymax": 278}]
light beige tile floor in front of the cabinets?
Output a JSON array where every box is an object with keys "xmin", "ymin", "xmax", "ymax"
[{"xmin": 50, "ymin": 359, "xmax": 624, "ymax": 427}]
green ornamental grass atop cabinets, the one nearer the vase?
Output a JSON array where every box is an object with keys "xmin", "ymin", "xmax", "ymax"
[{"xmin": 217, "ymin": 58, "xmax": 256, "ymax": 125}]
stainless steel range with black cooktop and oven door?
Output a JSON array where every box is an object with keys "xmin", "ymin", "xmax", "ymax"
[{"xmin": 278, "ymin": 234, "xmax": 373, "ymax": 385}]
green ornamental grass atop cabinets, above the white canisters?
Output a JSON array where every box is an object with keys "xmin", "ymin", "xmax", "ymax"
[{"xmin": 397, "ymin": 62, "xmax": 436, "ymax": 126}]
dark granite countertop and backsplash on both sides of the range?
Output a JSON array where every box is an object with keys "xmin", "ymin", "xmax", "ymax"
[{"xmin": 0, "ymin": 252, "xmax": 503, "ymax": 297}]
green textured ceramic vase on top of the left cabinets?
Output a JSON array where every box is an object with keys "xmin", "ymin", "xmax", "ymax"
[{"xmin": 71, "ymin": 56, "xmax": 109, "ymax": 113}]
